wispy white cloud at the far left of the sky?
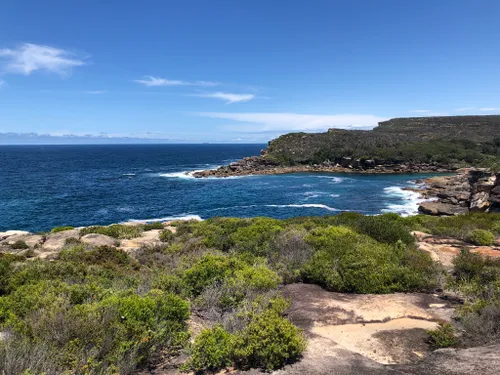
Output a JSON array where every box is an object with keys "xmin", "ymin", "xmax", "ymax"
[{"xmin": 0, "ymin": 43, "xmax": 85, "ymax": 75}]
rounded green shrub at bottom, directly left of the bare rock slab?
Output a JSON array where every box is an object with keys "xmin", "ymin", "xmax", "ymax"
[{"xmin": 233, "ymin": 310, "xmax": 306, "ymax": 370}]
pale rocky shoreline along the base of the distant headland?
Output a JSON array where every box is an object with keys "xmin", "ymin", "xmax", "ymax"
[{"xmin": 191, "ymin": 156, "xmax": 457, "ymax": 178}]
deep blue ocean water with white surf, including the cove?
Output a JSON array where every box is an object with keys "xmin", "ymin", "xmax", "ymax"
[{"xmin": 0, "ymin": 145, "xmax": 438, "ymax": 231}]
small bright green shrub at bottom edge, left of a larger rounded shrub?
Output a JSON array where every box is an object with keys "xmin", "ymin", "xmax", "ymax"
[{"xmin": 185, "ymin": 325, "xmax": 233, "ymax": 372}]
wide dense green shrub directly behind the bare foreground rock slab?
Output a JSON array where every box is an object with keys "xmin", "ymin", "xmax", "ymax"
[{"xmin": 303, "ymin": 227, "xmax": 437, "ymax": 293}]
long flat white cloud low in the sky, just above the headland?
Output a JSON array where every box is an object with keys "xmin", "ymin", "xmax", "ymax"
[{"xmin": 195, "ymin": 112, "xmax": 388, "ymax": 133}]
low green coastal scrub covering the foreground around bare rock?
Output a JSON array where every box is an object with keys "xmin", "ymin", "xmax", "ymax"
[{"xmin": 0, "ymin": 213, "xmax": 500, "ymax": 375}]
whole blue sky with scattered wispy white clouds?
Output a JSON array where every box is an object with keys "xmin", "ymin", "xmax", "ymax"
[{"xmin": 0, "ymin": 0, "xmax": 500, "ymax": 142}]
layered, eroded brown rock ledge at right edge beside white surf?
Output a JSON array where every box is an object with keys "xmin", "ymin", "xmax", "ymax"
[{"xmin": 419, "ymin": 168, "xmax": 500, "ymax": 215}]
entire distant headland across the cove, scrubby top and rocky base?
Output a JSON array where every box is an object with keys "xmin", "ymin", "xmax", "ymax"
[{"xmin": 197, "ymin": 115, "xmax": 500, "ymax": 177}]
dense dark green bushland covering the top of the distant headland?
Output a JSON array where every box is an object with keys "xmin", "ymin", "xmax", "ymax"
[{"xmin": 265, "ymin": 116, "xmax": 500, "ymax": 166}]
